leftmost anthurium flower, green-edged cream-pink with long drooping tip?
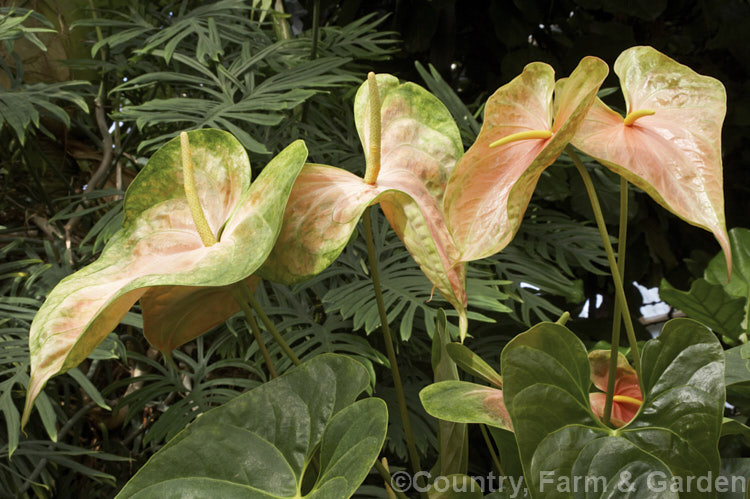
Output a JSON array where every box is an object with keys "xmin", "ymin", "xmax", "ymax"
[{"xmin": 23, "ymin": 130, "xmax": 307, "ymax": 424}]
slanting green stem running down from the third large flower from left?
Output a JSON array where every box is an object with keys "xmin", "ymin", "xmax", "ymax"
[{"xmin": 565, "ymin": 146, "xmax": 642, "ymax": 379}]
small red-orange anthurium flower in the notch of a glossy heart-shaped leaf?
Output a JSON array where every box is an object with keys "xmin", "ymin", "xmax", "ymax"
[{"xmin": 589, "ymin": 350, "xmax": 643, "ymax": 428}]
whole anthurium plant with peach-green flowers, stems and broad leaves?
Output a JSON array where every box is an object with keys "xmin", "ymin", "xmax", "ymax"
[{"xmin": 23, "ymin": 47, "xmax": 750, "ymax": 499}]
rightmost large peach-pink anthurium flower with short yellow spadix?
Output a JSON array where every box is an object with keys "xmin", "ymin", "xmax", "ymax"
[{"xmin": 572, "ymin": 47, "xmax": 732, "ymax": 271}]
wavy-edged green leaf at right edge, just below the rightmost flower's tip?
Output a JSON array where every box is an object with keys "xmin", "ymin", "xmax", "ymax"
[{"xmin": 659, "ymin": 278, "xmax": 746, "ymax": 341}]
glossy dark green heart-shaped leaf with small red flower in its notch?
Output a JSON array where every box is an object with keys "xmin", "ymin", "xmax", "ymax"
[{"xmin": 502, "ymin": 319, "xmax": 724, "ymax": 498}]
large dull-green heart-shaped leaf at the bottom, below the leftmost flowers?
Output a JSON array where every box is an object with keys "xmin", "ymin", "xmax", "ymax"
[{"xmin": 117, "ymin": 354, "xmax": 388, "ymax": 499}]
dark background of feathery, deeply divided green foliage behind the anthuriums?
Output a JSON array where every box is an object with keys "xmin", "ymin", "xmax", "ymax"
[{"xmin": 0, "ymin": 0, "xmax": 750, "ymax": 497}]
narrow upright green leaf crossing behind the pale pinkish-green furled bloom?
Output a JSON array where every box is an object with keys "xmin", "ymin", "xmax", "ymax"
[{"xmin": 432, "ymin": 309, "xmax": 469, "ymax": 476}]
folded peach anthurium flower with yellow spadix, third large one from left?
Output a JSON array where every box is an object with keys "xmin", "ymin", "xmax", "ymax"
[{"xmin": 443, "ymin": 57, "xmax": 608, "ymax": 262}]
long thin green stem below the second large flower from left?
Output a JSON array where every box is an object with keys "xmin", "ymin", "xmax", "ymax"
[{"xmin": 364, "ymin": 206, "xmax": 422, "ymax": 475}]
